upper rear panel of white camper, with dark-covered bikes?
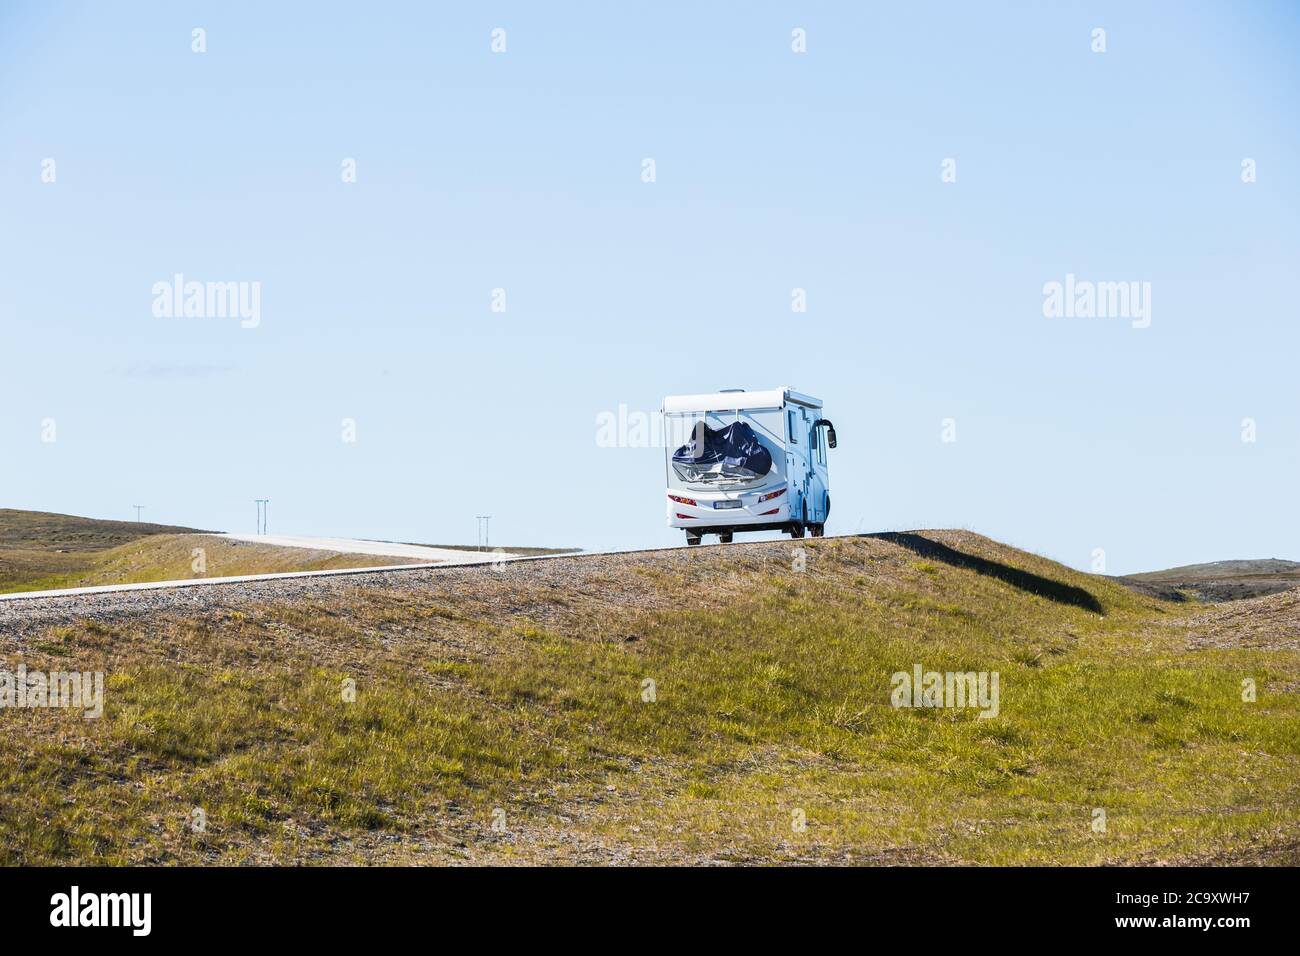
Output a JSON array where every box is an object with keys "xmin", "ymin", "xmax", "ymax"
[{"xmin": 664, "ymin": 408, "xmax": 783, "ymax": 488}]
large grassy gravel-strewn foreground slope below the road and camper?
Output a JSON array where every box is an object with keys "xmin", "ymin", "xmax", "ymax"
[{"xmin": 0, "ymin": 532, "xmax": 1300, "ymax": 865}]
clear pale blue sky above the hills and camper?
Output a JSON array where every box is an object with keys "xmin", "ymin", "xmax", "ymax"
[{"xmin": 0, "ymin": 0, "xmax": 1300, "ymax": 574}]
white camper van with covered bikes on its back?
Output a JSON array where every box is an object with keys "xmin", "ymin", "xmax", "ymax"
[{"xmin": 662, "ymin": 386, "xmax": 836, "ymax": 545}]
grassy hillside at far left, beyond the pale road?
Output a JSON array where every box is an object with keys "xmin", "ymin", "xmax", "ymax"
[{"xmin": 0, "ymin": 509, "xmax": 412, "ymax": 593}]
